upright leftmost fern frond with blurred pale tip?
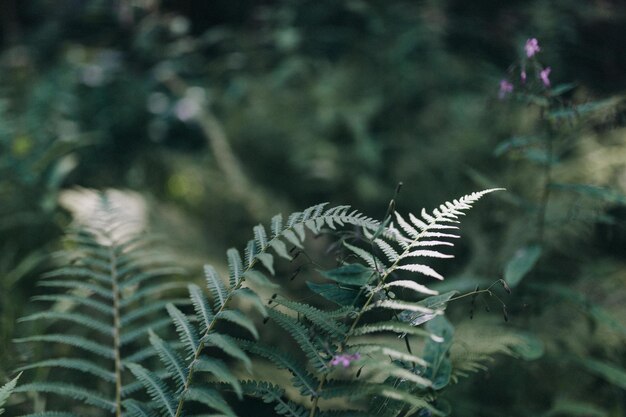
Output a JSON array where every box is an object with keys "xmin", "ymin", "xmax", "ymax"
[{"xmin": 16, "ymin": 194, "xmax": 187, "ymax": 416}]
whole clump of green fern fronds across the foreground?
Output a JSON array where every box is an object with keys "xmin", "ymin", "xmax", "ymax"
[{"xmin": 11, "ymin": 190, "xmax": 502, "ymax": 417}]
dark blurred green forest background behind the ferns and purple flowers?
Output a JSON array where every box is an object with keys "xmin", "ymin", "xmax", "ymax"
[{"xmin": 0, "ymin": 0, "xmax": 626, "ymax": 417}]
